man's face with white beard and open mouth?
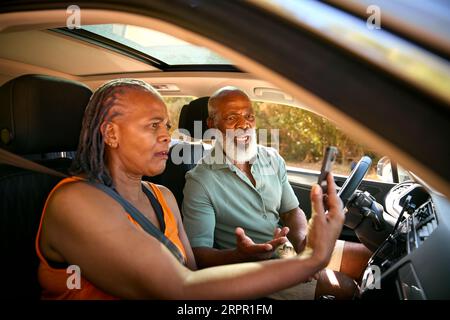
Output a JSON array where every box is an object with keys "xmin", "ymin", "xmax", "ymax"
[{"xmin": 210, "ymin": 91, "xmax": 256, "ymax": 163}]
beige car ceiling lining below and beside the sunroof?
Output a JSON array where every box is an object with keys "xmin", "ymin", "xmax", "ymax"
[{"xmin": 0, "ymin": 30, "xmax": 300, "ymax": 105}]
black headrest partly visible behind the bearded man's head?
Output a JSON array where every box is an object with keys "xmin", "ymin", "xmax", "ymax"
[{"xmin": 178, "ymin": 97, "xmax": 209, "ymax": 139}]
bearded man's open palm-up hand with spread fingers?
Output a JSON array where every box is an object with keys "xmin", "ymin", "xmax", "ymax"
[{"xmin": 235, "ymin": 227, "xmax": 289, "ymax": 261}]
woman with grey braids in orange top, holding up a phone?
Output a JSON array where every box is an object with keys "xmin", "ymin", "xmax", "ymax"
[{"xmin": 36, "ymin": 79, "xmax": 344, "ymax": 299}]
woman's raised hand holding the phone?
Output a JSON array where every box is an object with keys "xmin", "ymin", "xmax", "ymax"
[{"xmin": 307, "ymin": 174, "xmax": 345, "ymax": 267}]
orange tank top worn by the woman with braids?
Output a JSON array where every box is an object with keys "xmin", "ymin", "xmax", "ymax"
[{"xmin": 36, "ymin": 177, "xmax": 186, "ymax": 300}]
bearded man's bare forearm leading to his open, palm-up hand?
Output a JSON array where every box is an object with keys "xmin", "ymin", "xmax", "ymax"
[{"xmin": 192, "ymin": 247, "xmax": 249, "ymax": 269}]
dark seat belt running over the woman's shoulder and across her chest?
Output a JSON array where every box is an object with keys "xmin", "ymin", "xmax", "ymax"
[{"xmin": 0, "ymin": 148, "xmax": 186, "ymax": 265}]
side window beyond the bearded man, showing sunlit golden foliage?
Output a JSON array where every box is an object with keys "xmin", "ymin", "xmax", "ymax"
[{"xmin": 253, "ymin": 101, "xmax": 381, "ymax": 180}]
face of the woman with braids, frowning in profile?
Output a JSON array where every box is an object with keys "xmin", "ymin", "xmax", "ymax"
[{"xmin": 104, "ymin": 88, "xmax": 170, "ymax": 176}]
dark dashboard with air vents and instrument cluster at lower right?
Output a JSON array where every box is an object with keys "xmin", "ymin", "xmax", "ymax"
[{"xmin": 361, "ymin": 181, "xmax": 450, "ymax": 300}]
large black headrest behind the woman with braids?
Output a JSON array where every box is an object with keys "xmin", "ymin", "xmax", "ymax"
[{"xmin": 0, "ymin": 75, "xmax": 92, "ymax": 154}]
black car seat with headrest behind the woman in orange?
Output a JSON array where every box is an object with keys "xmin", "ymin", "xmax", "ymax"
[{"xmin": 0, "ymin": 75, "xmax": 92, "ymax": 299}]
